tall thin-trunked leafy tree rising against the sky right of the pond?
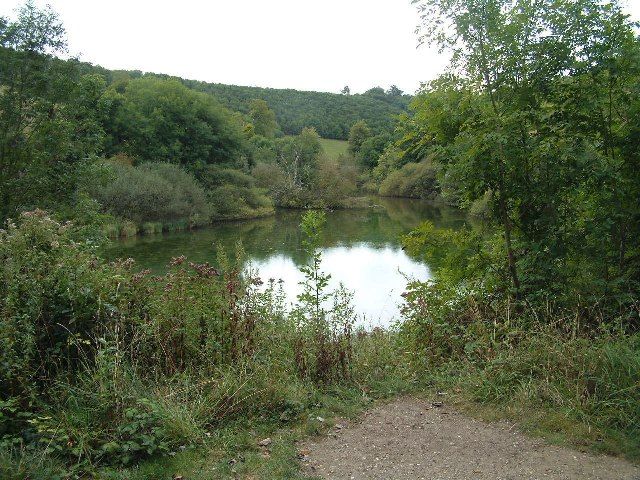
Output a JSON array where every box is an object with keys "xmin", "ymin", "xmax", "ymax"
[{"xmin": 414, "ymin": 0, "xmax": 633, "ymax": 296}]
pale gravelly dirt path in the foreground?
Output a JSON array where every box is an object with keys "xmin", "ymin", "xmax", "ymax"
[{"xmin": 301, "ymin": 398, "xmax": 640, "ymax": 480}]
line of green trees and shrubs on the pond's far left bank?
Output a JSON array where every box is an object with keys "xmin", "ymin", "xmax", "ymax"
[{"xmin": 0, "ymin": 3, "xmax": 384, "ymax": 231}]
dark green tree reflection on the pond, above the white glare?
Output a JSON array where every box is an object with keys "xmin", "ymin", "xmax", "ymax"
[{"xmin": 105, "ymin": 198, "xmax": 464, "ymax": 272}]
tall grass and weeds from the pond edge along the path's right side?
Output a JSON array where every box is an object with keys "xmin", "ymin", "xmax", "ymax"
[{"xmin": 400, "ymin": 274, "xmax": 640, "ymax": 459}]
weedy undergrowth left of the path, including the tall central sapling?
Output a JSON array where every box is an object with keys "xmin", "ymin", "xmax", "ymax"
[{"xmin": 0, "ymin": 211, "xmax": 410, "ymax": 478}]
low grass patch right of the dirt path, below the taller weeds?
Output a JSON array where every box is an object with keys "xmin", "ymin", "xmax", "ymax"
[{"xmin": 404, "ymin": 332, "xmax": 640, "ymax": 463}]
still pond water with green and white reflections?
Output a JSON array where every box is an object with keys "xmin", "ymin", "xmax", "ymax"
[{"xmin": 105, "ymin": 198, "xmax": 464, "ymax": 327}]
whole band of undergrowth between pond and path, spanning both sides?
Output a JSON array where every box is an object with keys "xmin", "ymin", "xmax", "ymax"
[{"xmin": 0, "ymin": 211, "xmax": 640, "ymax": 479}]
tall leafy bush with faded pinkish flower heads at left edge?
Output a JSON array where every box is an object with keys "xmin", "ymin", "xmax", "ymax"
[{"xmin": 0, "ymin": 211, "xmax": 119, "ymax": 405}]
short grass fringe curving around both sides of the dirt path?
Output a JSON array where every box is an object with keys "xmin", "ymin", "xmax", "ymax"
[{"xmin": 99, "ymin": 372, "xmax": 637, "ymax": 480}]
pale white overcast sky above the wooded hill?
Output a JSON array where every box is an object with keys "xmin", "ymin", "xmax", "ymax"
[{"xmin": 0, "ymin": 0, "xmax": 640, "ymax": 93}]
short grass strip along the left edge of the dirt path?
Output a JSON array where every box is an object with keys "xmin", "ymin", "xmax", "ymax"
[{"xmin": 98, "ymin": 386, "xmax": 410, "ymax": 480}]
